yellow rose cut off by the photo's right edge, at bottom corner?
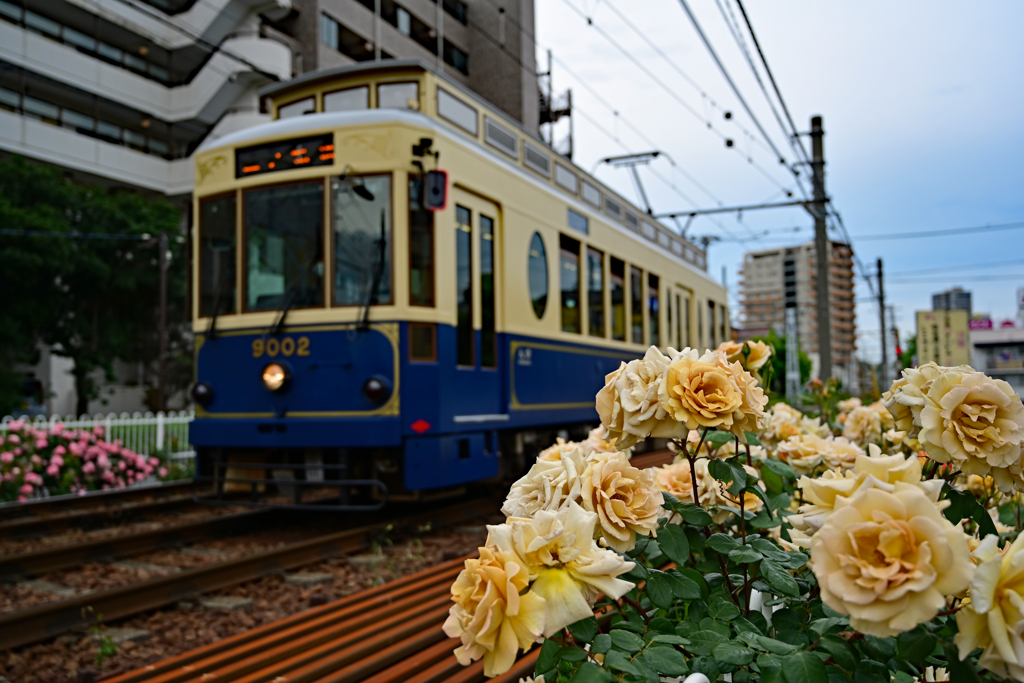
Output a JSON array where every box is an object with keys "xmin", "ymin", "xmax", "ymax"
[{"xmin": 953, "ymin": 533, "xmax": 1024, "ymax": 681}]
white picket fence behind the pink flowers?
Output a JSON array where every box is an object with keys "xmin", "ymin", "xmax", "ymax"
[{"xmin": 0, "ymin": 411, "xmax": 196, "ymax": 460}]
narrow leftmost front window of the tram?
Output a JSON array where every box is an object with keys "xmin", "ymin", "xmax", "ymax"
[{"xmin": 199, "ymin": 193, "xmax": 236, "ymax": 316}]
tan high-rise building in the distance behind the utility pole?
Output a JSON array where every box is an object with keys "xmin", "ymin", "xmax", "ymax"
[{"xmin": 737, "ymin": 242, "xmax": 857, "ymax": 376}]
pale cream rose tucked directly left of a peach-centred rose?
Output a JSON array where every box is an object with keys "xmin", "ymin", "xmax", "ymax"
[{"xmin": 502, "ymin": 444, "xmax": 587, "ymax": 517}]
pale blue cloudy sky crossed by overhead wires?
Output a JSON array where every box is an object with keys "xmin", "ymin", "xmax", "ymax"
[{"xmin": 536, "ymin": 0, "xmax": 1024, "ymax": 359}]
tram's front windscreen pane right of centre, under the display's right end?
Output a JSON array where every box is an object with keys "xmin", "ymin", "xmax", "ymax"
[{"xmin": 331, "ymin": 175, "xmax": 392, "ymax": 306}]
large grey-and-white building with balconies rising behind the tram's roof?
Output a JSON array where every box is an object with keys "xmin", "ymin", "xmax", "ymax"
[{"xmin": 0, "ymin": 0, "xmax": 539, "ymax": 198}]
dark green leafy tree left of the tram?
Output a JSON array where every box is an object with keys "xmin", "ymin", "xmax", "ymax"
[{"xmin": 0, "ymin": 157, "xmax": 185, "ymax": 414}]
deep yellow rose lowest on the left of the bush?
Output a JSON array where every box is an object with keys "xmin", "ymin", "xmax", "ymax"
[{"xmin": 444, "ymin": 547, "xmax": 545, "ymax": 677}]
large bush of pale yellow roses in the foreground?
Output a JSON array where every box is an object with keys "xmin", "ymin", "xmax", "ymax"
[{"xmin": 445, "ymin": 344, "xmax": 1024, "ymax": 683}]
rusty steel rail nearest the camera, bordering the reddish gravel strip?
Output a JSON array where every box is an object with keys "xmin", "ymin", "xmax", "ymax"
[{"xmin": 0, "ymin": 493, "xmax": 498, "ymax": 649}]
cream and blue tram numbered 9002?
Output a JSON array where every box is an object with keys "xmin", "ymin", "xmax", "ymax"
[{"xmin": 191, "ymin": 60, "xmax": 730, "ymax": 508}]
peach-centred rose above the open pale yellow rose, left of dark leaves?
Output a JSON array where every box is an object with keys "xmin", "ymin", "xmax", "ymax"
[{"xmin": 580, "ymin": 453, "xmax": 665, "ymax": 553}]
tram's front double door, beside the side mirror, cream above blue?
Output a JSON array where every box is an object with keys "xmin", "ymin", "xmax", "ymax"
[{"xmin": 449, "ymin": 187, "xmax": 506, "ymax": 423}]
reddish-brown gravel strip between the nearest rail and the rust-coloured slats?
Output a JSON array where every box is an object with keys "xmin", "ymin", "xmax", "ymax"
[{"xmin": 0, "ymin": 524, "xmax": 485, "ymax": 683}]
